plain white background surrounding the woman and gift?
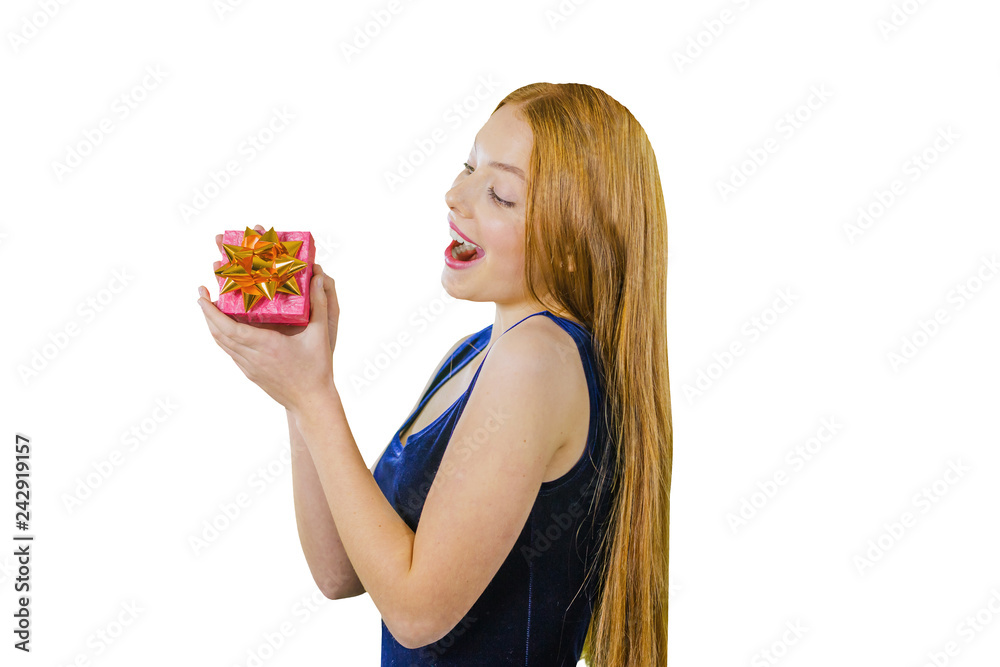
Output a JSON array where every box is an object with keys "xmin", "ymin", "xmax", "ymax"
[{"xmin": 0, "ymin": 0, "xmax": 1000, "ymax": 667}]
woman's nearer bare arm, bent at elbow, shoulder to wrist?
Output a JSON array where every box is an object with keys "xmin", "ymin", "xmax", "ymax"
[{"xmin": 292, "ymin": 320, "xmax": 573, "ymax": 648}]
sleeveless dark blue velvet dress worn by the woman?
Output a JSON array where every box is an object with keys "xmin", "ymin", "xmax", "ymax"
[{"xmin": 374, "ymin": 311, "xmax": 614, "ymax": 667}]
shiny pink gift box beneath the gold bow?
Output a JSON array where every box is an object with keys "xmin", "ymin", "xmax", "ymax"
[{"xmin": 215, "ymin": 230, "xmax": 316, "ymax": 326}]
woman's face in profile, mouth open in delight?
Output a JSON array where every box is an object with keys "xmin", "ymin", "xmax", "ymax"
[{"xmin": 441, "ymin": 104, "xmax": 533, "ymax": 304}]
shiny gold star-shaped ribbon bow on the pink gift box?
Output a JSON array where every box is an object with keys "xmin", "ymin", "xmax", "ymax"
[{"xmin": 215, "ymin": 227, "xmax": 306, "ymax": 312}]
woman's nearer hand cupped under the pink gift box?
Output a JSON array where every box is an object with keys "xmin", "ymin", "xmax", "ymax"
[{"xmin": 198, "ymin": 264, "xmax": 339, "ymax": 413}]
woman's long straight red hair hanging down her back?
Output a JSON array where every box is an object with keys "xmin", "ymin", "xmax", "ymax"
[{"xmin": 494, "ymin": 83, "xmax": 673, "ymax": 667}]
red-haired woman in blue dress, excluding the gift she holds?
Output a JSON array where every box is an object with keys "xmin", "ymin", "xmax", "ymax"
[{"xmin": 199, "ymin": 83, "xmax": 673, "ymax": 667}]
